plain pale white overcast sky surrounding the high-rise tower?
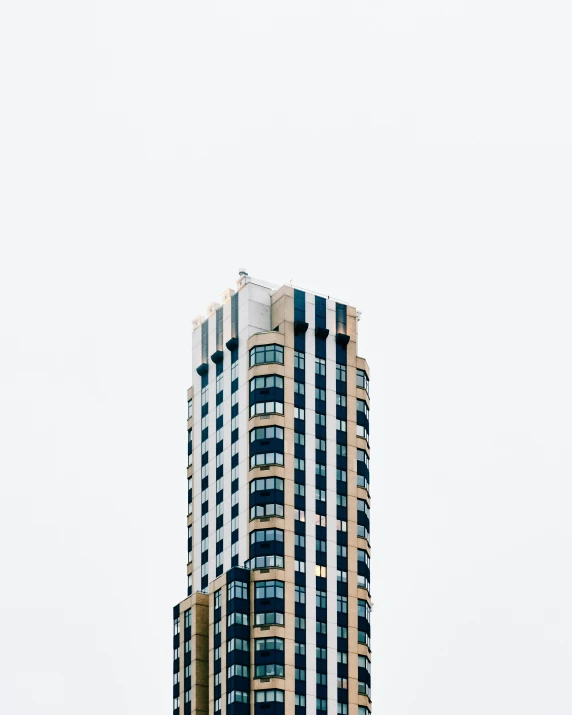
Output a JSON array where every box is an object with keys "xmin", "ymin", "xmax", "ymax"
[{"xmin": 0, "ymin": 0, "xmax": 572, "ymax": 715}]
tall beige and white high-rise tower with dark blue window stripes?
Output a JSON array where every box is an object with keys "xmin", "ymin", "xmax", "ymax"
[{"xmin": 173, "ymin": 272, "xmax": 371, "ymax": 715}]
